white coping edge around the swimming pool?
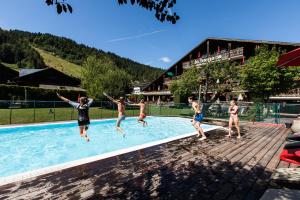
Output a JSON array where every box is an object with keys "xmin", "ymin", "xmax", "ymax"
[{"xmin": 0, "ymin": 117, "xmax": 222, "ymax": 186}]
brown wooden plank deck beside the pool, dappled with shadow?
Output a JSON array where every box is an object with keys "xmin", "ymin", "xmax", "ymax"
[{"xmin": 0, "ymin": 123, "xmax": 296, "ymax": 200}]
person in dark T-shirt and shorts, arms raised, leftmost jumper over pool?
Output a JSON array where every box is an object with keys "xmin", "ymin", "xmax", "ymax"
[{"xmin": 56, "ymin": 93, "xmax": 93, "ymax": 142}]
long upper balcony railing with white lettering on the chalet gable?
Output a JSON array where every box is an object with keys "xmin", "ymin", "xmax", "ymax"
[{"xmin": 182, "ymin": 47, "xmax": 244, "ymax": 69}]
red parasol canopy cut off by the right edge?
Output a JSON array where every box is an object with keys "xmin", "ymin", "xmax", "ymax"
[{"xmin": 277, "ymin": 48, "xmax": 300, "ymax": 67}]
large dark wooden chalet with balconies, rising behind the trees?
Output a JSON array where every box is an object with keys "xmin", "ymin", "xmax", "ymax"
[{"xmin": 141, "ymin": 38, "xmax": 300, "ymax": 102}]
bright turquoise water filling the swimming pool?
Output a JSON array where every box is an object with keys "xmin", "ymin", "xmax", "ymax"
[{"xmin": 0, "ymin": 117, "xmax": 217, "ymax": 177}]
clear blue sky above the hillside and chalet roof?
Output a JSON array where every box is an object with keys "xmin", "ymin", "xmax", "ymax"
[{"xmin": 0, "ymin": 0, "xmax": 300, "ymax": 68}]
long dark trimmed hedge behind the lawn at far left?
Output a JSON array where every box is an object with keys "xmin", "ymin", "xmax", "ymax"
[{"xmin": 0, "ymin": 84, "xmax": 86, "ymax": 101}]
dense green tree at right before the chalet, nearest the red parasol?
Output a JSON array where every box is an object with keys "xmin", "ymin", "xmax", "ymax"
[{"xmin": 241, "ymin": 46, "xmax": 296, "ymax": 100}]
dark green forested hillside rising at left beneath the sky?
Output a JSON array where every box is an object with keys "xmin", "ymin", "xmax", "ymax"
[{"xmin": 0, "ymin": 29, "xmax": 162, "ymax": 82}]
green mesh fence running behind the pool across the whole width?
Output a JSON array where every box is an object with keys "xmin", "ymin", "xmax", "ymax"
[{"xmin": 0, "ymin": 101, "xmax": 300, "ymax": 125}]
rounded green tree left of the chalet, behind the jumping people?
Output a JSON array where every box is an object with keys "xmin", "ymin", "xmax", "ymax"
[{"xmin": 82, "ymin": 56, "xmax": 131, "ymax": 99}]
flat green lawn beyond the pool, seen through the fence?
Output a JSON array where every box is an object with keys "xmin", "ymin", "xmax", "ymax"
[{"xmin": 0, "ymin": 106, "xmax": 192, "ymax": 125}]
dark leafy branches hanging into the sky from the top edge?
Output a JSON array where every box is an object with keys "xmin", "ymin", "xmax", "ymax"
[{"xmin": 46, "ymin": 0, "xmax": 180, "ymax": 24}]
